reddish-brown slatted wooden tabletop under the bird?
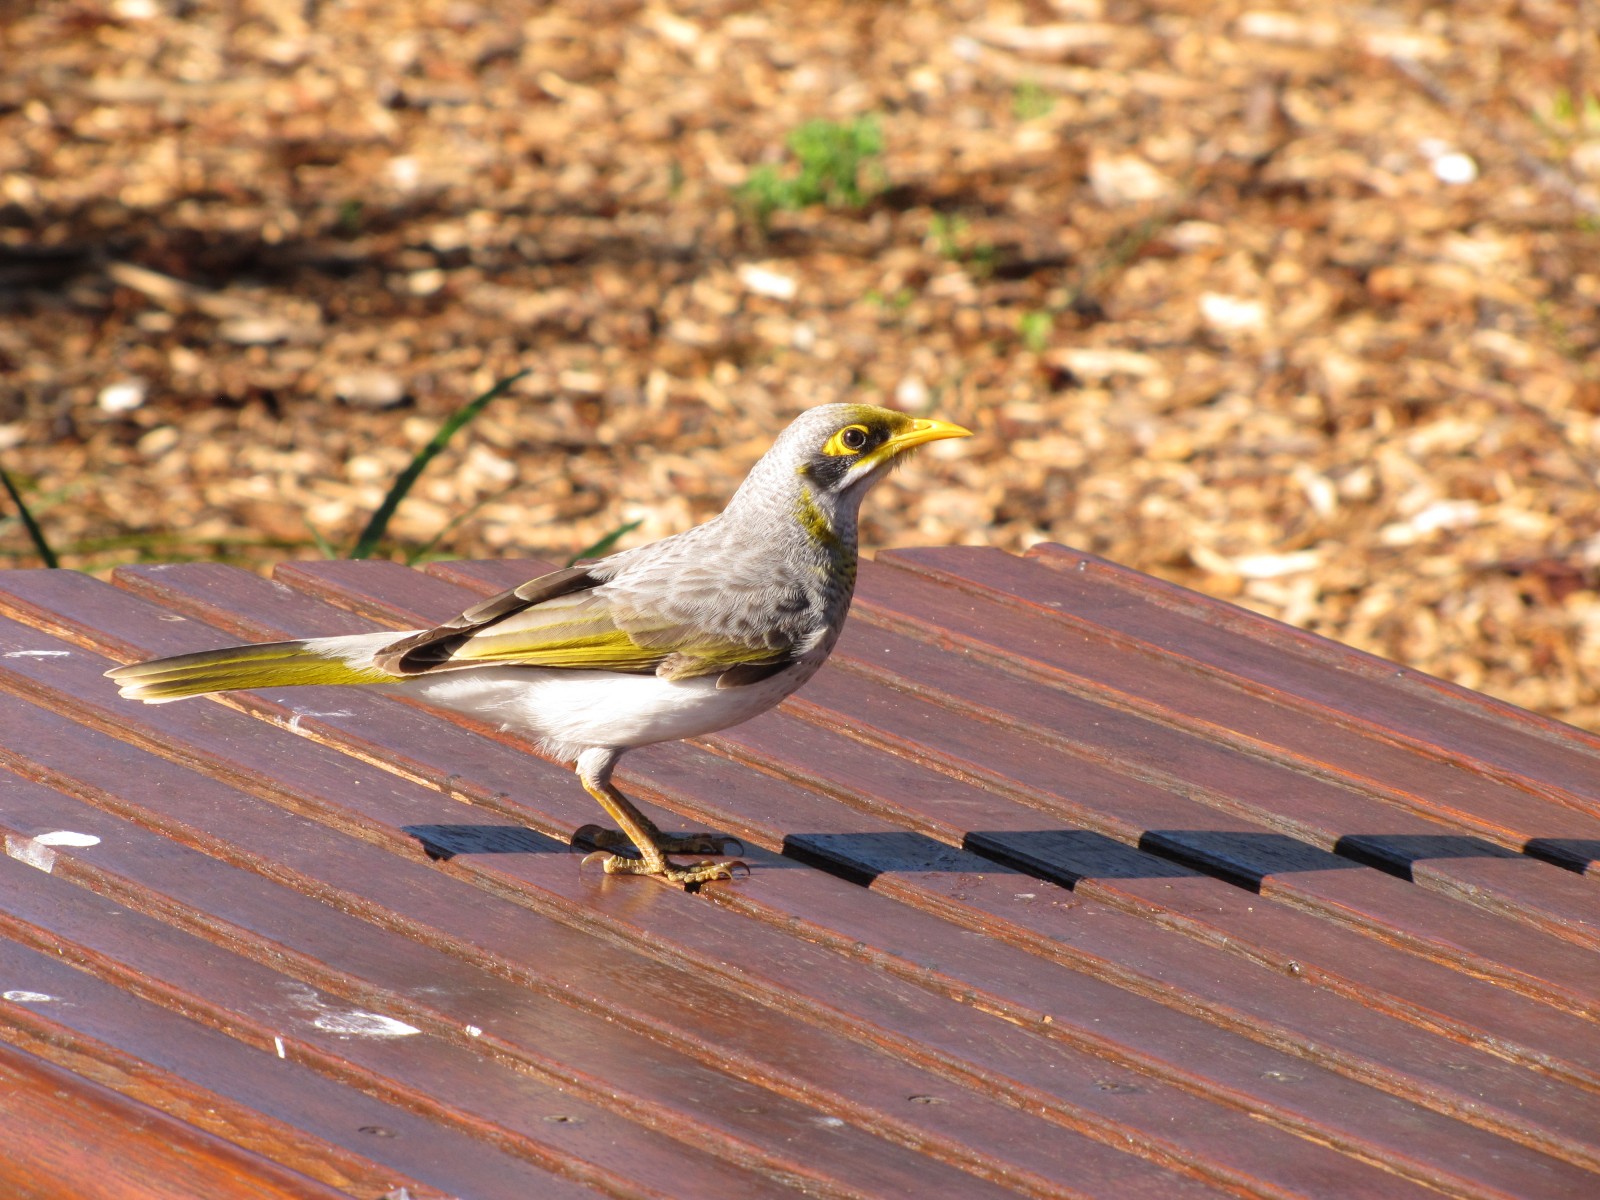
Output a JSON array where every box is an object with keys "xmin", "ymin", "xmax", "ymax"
[{"xmin": 0, "ymin": 547, "xmax": 1600, "ymax": 1200}]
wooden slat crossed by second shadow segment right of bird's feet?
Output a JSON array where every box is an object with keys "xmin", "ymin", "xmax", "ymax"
[{"xmin": 715, "ymin": 706, "xmax": 1600, "ymax": 1090}]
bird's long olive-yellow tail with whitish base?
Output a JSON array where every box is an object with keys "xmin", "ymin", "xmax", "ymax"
[{"xmin": 106, "ymin": 632, "xmax": 408, "ymax": 704}]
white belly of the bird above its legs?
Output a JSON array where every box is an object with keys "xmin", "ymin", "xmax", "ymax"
[{"xmin": 394, "ymin": 662, "xmax": 821, "ymax": 760}]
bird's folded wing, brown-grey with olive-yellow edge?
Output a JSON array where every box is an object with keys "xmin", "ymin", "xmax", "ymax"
[{"xmin": 374, "ymin": 566, "xmax": 789, "ymax": 686}]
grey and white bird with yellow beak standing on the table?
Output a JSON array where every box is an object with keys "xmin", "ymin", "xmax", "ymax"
[{"xmin": 106, "ymin": 405, "xmax": 970, "ymax": 885}]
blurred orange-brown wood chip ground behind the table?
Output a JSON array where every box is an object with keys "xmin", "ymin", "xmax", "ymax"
[{"xmin": 0, "ymin": 0, "xmax": 1600, "ymax": 728}]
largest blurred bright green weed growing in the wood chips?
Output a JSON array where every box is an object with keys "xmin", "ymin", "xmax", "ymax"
[{"xmin": 738, "ymin": 115, "xmax": 885, "ymax": 226}]
